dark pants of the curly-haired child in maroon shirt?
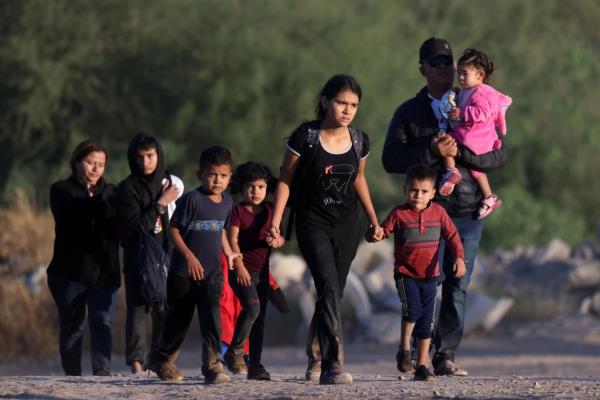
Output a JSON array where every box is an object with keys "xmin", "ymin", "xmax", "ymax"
[{"xmin": 229, "ymin": 268, "xmax": 271, "ymax": 365}]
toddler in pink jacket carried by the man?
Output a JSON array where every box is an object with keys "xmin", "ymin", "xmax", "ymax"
[{"xmin": 439, "ymin": 49, "xmax": 512, "ymax": 219}]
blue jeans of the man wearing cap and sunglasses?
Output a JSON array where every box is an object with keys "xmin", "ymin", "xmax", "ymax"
[{"xmin": 432, "ymin": 217, "xmax": 483, "ymax": 367}]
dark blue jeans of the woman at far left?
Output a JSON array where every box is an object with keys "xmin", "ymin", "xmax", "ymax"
[{"xmin": 48, "ymin": 275, "xmax": 119, "ymax": 375}]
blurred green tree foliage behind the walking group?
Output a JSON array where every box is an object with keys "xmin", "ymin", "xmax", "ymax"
[{"xmin": 0, "ymin": 0, "xmax": 600, "ymax": 248}]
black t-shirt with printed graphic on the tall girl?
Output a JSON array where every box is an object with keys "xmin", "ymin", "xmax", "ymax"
[{"xmin": 287, "ymin": 127, "xmax": 369, "ymax": 223}]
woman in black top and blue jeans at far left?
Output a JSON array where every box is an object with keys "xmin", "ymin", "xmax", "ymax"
[{"xmin": 48, "ymin": 140, "xmax": 121, "ymax": 375}]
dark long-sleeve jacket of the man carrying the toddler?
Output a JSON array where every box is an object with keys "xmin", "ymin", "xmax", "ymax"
[{"xmin": 381, "ymin": 87, "xmax": 507, "ymax": 217}]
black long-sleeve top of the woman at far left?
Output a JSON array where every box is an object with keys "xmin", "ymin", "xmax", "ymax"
[{"xmin": 48, "ymin": 177, "xmax": 121, "ymax": 287}]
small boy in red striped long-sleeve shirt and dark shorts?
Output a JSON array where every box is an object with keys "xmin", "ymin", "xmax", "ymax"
[{"xmin": 381, "ymin": 165, "xmax": 466, "ymax": 381}]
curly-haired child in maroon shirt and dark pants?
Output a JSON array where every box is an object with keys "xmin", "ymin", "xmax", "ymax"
[{"xmin": 223, "ymin": 161, "xmax": 284, "ymax": 380}]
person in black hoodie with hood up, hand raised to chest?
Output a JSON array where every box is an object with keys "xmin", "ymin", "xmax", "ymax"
[{"xmin": 118, "ymin": 133, "xmax": 183, "ymax": 373}]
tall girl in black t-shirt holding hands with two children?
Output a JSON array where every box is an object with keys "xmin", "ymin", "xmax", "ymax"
[{"xmin": 270, "ymin": 75, "xmax": 382, "ymax": 384}]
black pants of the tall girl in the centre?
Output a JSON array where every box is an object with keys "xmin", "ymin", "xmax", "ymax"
[{"xmin": 296, "ymin": 217, "xmax": 360, "ymax": 370}]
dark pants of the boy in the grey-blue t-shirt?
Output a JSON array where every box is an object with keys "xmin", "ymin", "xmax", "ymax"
[{"xmin": 157, "ymin": 274, "xmax": 223, "ymax": 371}]
